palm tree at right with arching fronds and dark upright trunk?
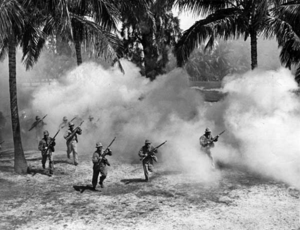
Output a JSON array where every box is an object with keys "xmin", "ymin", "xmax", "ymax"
[{"xmin": 175, "ymin": 0, "xmax": 274, "ymax": 69}]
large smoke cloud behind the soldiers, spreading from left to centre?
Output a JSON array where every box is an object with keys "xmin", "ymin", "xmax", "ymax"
[{"xmin": 32, "ymin": 61, "xmax": 223, "ymax": 183}]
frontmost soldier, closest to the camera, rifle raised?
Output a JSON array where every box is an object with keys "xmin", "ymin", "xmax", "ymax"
[{"xmin": 92, "ymin": 142, "xmax": 112, "ymax": 190}]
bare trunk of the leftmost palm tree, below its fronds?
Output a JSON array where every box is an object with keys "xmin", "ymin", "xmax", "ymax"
[{"xmin": 8, "ymin": 38, "xmax": 28, "ymax": 174}]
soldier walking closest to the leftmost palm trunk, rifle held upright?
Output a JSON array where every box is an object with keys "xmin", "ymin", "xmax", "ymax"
[{"xmin": 38, "ymin": 130, "xmax": 55, "ymax": 175}]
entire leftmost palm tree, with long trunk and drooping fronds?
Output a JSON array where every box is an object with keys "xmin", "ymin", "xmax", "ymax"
[{"xmin": 0, "ymin": 0, "xmax": 41, "ymax": 173}]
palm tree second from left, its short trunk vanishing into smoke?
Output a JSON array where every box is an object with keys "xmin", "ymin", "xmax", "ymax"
[{"xmin": 36, "ymin": 0, "xmax": 119, "ymax": 65}]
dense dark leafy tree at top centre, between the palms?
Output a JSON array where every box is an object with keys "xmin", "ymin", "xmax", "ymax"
[{"xmin": 120, "ymin": 1, "xmax": 181, "ymax": 80}]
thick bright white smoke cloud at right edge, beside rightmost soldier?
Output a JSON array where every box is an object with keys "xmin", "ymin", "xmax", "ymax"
[{"xmin": 216, "ymin": 69, "xmax": 300, "ymax": 188}]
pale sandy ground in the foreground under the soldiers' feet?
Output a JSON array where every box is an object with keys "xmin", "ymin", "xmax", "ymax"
[{"xmin": 0, "ymin": 150, "xmax": 300, "ymax": 230}]
